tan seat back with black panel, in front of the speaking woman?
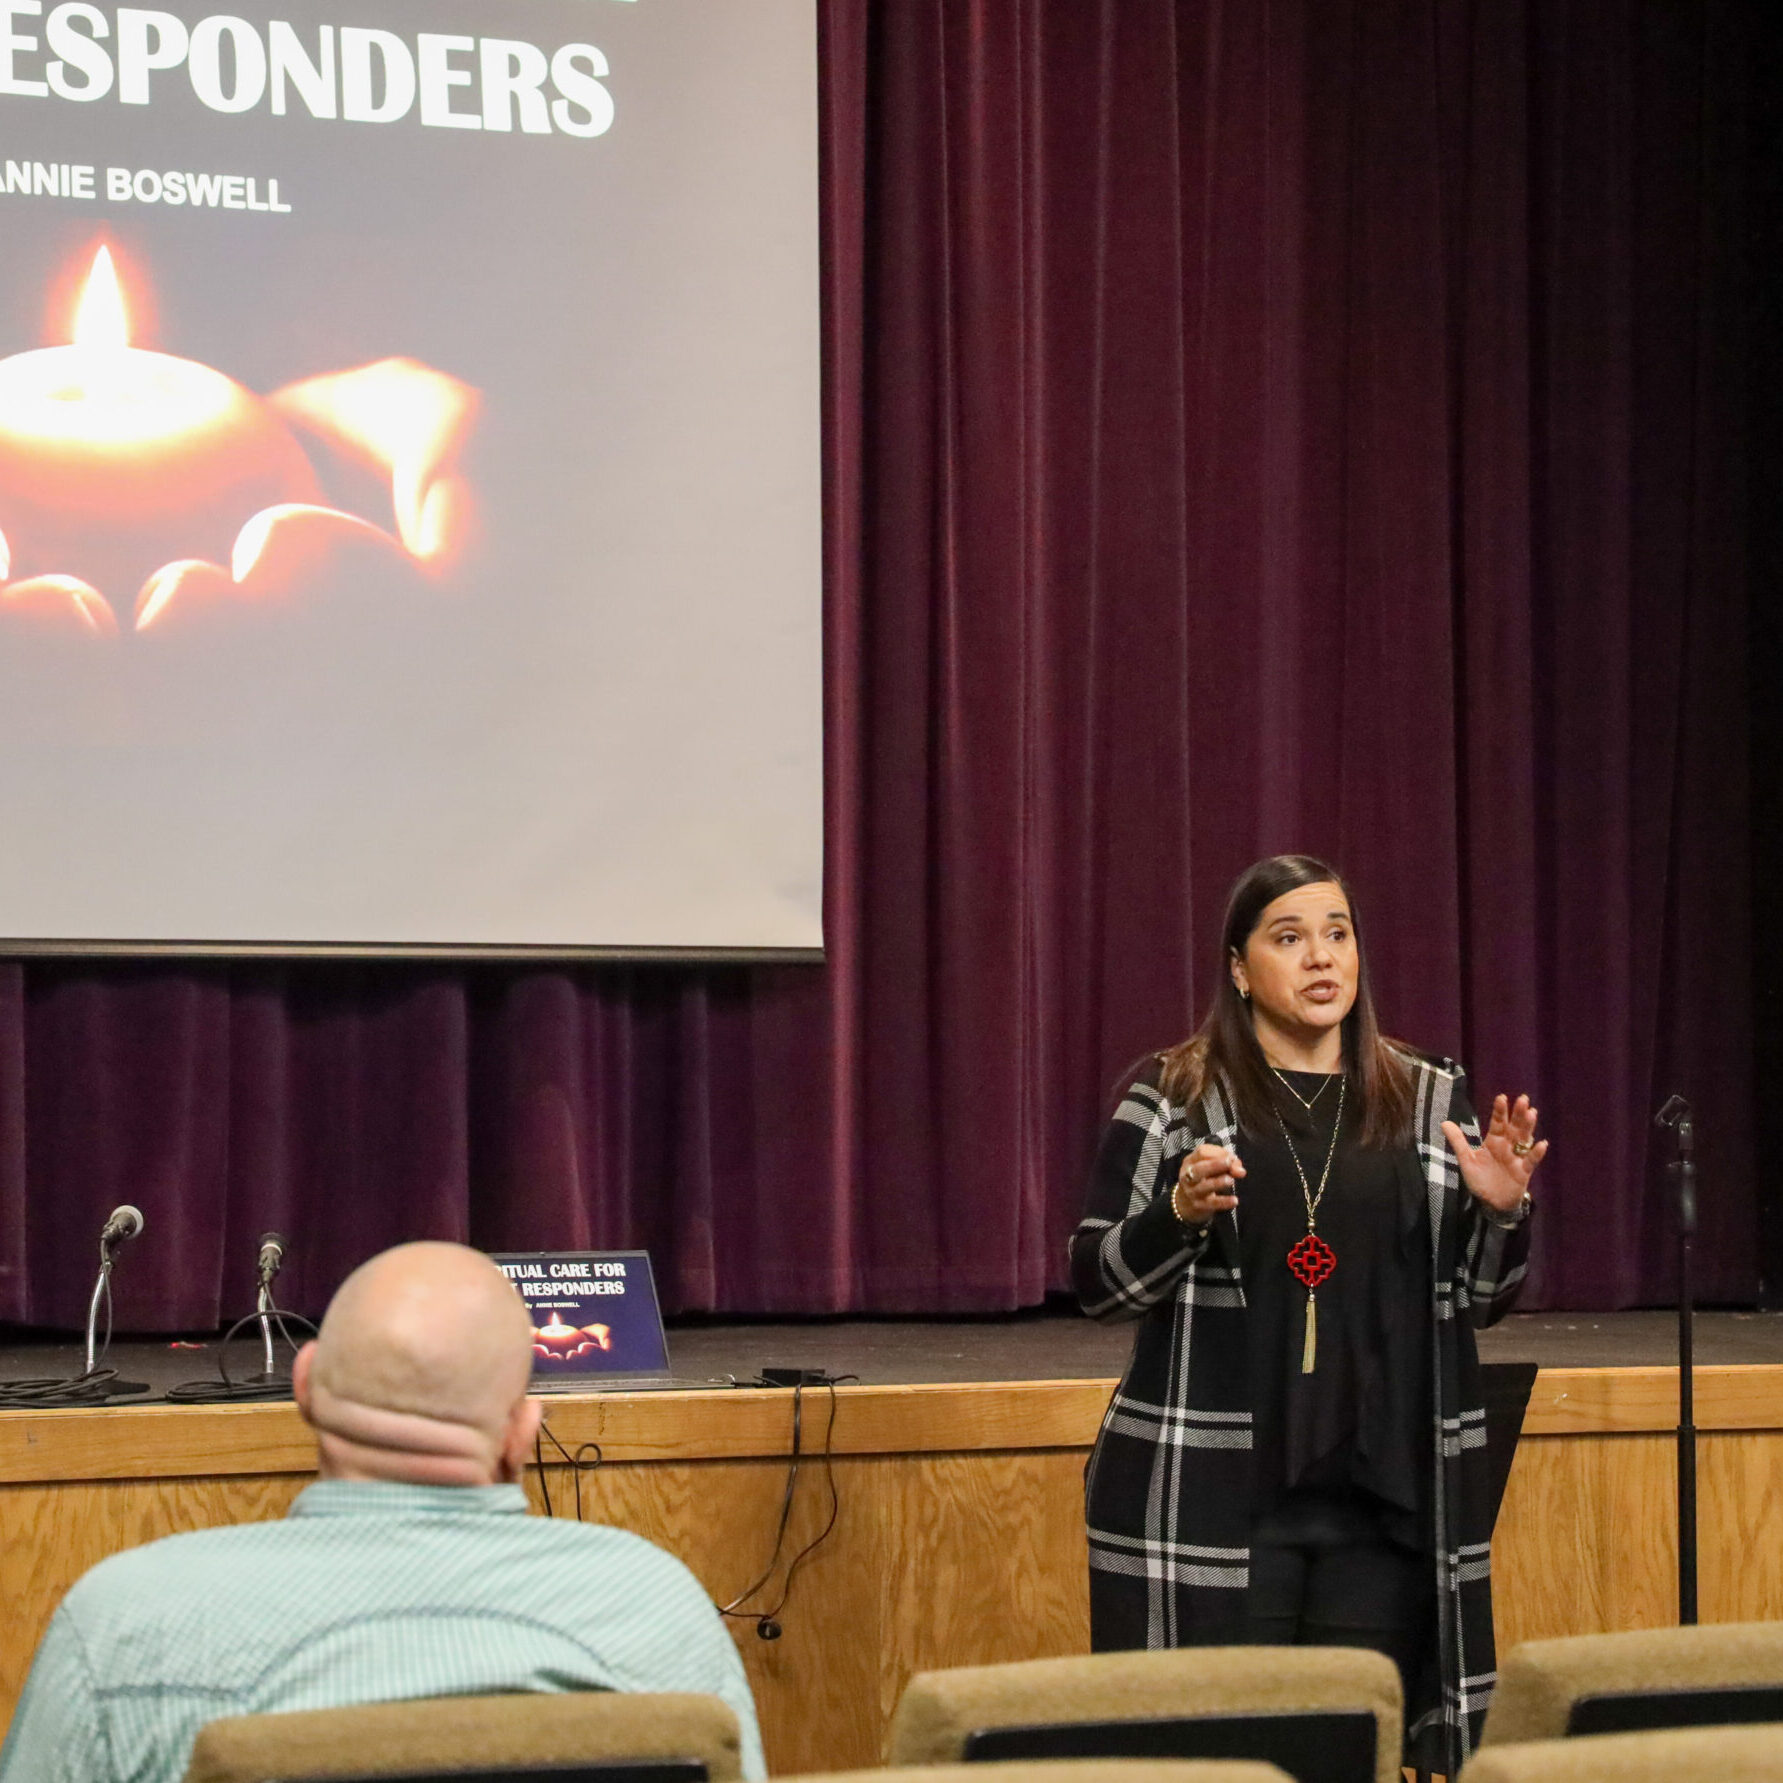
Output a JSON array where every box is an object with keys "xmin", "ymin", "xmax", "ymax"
[{"xmin": 890, "ymin": 1647, "xmax": 1401, "ymax": 1783}]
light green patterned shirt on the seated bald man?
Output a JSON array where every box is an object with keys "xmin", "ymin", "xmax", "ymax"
[{"xmin": 0, "ymin": 1480, "xmax": 765, "ymax": 1783}]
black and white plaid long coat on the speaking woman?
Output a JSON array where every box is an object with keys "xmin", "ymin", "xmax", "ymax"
[{"xmin": 1072, "ymin": 1056, "xmax": 1530, "ymax": 1776}]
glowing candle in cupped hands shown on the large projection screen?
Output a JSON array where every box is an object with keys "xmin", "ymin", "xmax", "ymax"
[{"xmin": 0, "ymin": 242, "xmax": 478, "ymax": 638}]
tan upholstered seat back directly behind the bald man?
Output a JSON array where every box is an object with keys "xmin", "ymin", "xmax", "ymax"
[{"xmin": 185, "ymin": 1690, "xmax": 742, "ymax": 1783}]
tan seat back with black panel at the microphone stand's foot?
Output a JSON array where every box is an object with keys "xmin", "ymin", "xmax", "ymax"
[{"xmin": 1480, "ymin": 1623, "xmax": 1783, "ymax": 1751}]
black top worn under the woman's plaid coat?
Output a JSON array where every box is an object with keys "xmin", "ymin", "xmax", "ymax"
[{"xmin": 1237, "ymin": 1072, "xmax": 1435, "ymax": 1546}]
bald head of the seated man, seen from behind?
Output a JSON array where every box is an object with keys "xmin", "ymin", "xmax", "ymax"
[{"xmin": 294, "ymin": 1243, "xmax": 538, "ymax": 1485}]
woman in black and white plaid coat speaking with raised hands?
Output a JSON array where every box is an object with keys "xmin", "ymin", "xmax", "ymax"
[{"xmin": 1072, "ymin": 854, "xmax": 1548, "ymax": 1776}]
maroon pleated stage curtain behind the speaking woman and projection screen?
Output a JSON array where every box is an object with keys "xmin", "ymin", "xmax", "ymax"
[{"xmin": 0, "ymin": 0, "xmax": 1754, "ymax": 1330}]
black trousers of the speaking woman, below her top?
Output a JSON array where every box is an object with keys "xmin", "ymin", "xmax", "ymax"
[{"xmin": 1245, "ymin": 1492, "xmax": 1435, "ymax": 1703}]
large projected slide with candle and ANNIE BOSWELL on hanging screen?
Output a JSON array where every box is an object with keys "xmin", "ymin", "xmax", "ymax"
[{"xmin": 0, "ymin": 0, "xmax": 822, "ymax": 952}]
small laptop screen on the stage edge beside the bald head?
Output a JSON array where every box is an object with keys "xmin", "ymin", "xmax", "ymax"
[{"xmin": 492, "ymin": 1250, "xmax": 669, "ymax": 1387}]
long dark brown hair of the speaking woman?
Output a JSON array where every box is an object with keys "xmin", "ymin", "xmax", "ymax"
[{"xmin": 1163, "ymin": 854, "xmax": 1412, "ymax": 1146}]
